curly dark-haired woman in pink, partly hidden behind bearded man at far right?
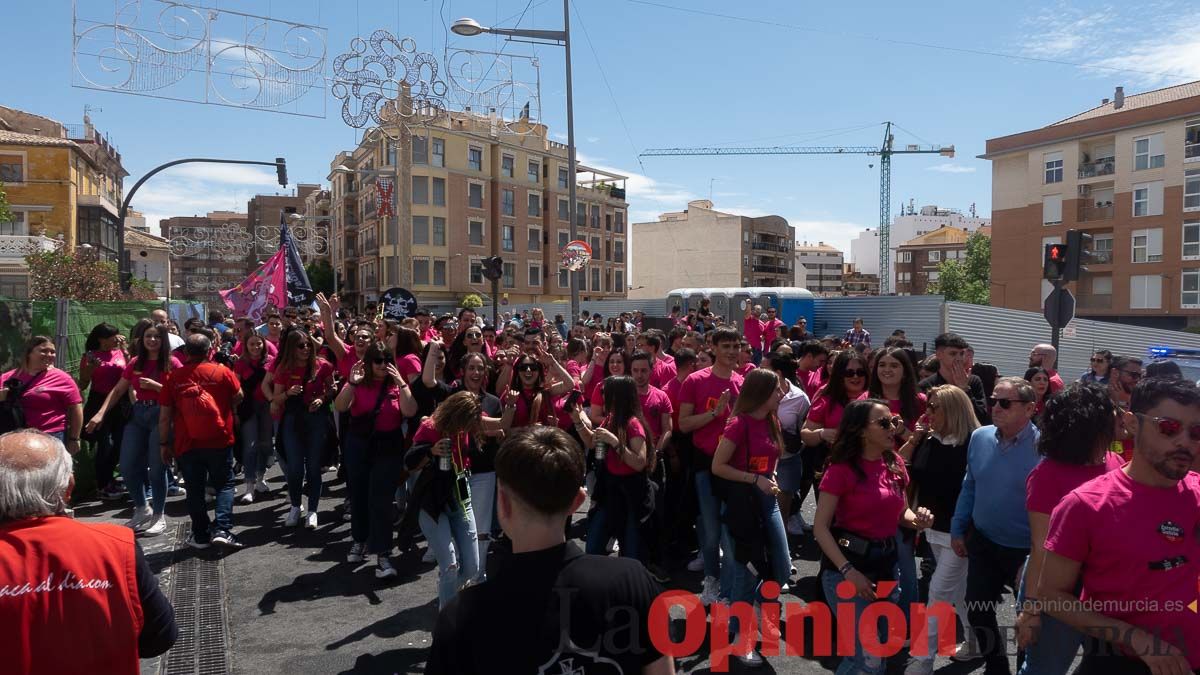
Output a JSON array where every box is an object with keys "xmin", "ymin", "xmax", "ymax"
[{"xmin": 1016, "ymin": 383, "xmax": 1123, "ymax": 675}]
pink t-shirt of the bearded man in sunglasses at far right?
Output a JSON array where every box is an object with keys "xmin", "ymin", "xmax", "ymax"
[{"xmin": 1045, "ymin": 470, "xmax": 1200, "ymax": 669}]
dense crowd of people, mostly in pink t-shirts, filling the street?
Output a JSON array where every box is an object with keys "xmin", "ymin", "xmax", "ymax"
[{"xmin": 0, "ymin": 294, "xmax": 1200, "ymax": 675}]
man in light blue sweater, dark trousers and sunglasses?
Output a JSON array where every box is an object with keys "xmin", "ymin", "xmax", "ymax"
[{"xmin": 950, "ymin": 377, "xmax": 1042, "ymax": 673}]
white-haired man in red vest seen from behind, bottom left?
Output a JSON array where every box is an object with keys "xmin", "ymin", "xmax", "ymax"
[{"xmin": 0, "ymin": 429, "xmax": 179, "ymax": 675}]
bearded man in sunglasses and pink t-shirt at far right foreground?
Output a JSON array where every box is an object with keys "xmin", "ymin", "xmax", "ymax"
[{"xmin": 1025, "ymin": 378, "xmax": 1200, "ymax": 675}]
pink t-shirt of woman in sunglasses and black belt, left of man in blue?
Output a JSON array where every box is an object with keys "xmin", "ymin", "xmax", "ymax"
[{"xmin": 821, "ymin": 456, "xmax": 908, "ymax": 539}]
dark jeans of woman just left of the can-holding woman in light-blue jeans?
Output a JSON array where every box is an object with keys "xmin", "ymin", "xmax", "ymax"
[{"xmin": 343, "ymin": 434, "xmax": 404, "ymax": 555}]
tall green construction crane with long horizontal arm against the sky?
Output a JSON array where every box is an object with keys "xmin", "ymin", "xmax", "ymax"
[{"xmin": 638, "ymin": 123, "xmax": 954, "ymax": 295}]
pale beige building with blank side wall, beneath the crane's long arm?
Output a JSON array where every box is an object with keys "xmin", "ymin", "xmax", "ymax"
[{"xmin": 630, "ymin": 199, "xmax": 796, "ymax": 299}]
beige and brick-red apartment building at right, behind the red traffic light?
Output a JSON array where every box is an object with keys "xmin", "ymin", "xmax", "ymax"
[{"xmin": 982, "ymin": 82, "xmax": 1200, "ymax": 329}]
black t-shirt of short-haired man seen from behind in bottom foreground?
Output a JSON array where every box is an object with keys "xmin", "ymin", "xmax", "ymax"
[{"xmin": 425, "ymin": 543, "xmax": 662, "ymax": 675}]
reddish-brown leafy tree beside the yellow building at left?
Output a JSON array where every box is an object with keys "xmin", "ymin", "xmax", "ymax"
[{"xmin": 25, "ymin": 249, "xmax": 156, "ymax": 301}]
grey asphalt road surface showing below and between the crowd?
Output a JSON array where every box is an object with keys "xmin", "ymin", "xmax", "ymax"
[{"xmin": 76, "ymin": 467, "xmax": 1015, "ymax": 675}]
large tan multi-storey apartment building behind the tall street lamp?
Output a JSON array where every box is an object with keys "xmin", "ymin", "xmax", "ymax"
[{"xmin": 329, "ymin": 113, "xmax": 629, "ymax": 309}]
